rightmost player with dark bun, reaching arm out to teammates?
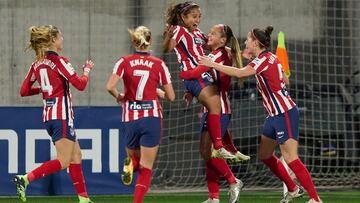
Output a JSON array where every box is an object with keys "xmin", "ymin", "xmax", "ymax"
[{"xmin": 200, "ymin": 26, "xmax": 321, "ymax": 203}]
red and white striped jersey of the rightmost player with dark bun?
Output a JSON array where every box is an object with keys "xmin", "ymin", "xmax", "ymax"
[{"xmin": 249, "ymin": 52, "xmax": 296, "ymax": 116}]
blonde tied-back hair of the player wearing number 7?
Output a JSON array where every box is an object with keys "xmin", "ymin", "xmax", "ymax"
[{"xmin": 128, "ymin": 26, "xmax": 151, "ymax": 49}]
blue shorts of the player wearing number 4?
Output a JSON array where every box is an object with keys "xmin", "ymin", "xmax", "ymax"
[{"xmin": 45, "ymin": 120, "xmax": 76, "ymax": 144}]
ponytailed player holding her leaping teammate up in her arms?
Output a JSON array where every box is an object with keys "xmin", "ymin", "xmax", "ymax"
[{"xmin": 181, "ymin": 24, "xmax": 250, "ymax": 203}]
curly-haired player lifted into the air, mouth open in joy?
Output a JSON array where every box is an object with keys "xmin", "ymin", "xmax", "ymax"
[{"xmin": 163, "ymin": 1, "xmax": 235, "ymax": 159}]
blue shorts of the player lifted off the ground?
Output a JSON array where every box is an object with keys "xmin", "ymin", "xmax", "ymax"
[{"xmin": 184, "ymin": 72, "xmax": 214, "ymax": 97}]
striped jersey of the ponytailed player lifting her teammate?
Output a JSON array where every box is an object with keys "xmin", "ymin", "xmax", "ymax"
[{"xmin": 203, "ymin": 47, "xmax": 232, "ymax": 114}]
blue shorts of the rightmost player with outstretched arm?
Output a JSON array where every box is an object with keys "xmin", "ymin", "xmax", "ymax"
[{"xmin": 263, "ymin": 107, "xmax": 299, "ymax": 144}]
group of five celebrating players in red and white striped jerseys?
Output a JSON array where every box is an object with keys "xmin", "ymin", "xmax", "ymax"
[{"xmin": 13, "ymin": 2, "xmax": 321, "ymax": 203}]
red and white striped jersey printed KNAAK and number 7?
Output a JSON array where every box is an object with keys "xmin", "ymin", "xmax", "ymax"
[{"xmin": 113, "ymin": 52, "xmax": 171, "ymax": 122}]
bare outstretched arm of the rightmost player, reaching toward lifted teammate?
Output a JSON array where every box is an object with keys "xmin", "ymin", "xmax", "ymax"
[{"xmin": 199, "ymin": 57, "xmax": 256, "ymax": 78}]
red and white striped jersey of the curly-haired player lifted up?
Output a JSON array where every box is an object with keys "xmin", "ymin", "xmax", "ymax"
[{"xmin": 173, "ymin": 25, "xmax": 207, "ymax": 71}]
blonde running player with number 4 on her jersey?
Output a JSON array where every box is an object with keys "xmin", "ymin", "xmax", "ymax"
[{"xmin": 14, "ymin": 25, "xmax": 94, "ymax": 203}]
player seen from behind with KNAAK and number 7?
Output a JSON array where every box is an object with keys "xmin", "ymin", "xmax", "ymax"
[{"xmin": 106, "ymin": 26, "xmax": 175, "ymax": 203}]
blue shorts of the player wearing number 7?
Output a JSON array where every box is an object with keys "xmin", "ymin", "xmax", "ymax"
[{"xmin": 124, "ymin": 117, "xmax": 162, "ymax": 149}]
